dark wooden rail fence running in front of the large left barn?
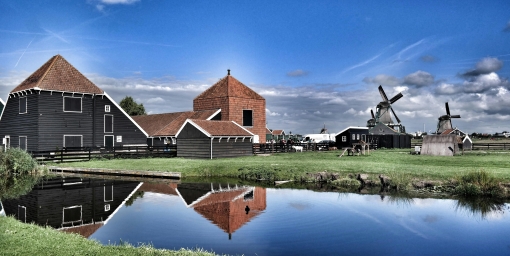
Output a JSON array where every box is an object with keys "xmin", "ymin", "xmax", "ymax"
[{"xmin": 29, "ymin": 145, "xmax": 177, "ymax": 163}]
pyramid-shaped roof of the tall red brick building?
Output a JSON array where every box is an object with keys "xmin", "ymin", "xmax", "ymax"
[{"xmin": 194, "ymin": 70, "xmax": 264, "ymax": 100}]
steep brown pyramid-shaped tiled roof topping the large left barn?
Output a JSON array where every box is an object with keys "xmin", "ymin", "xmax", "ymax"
[{"xmin": 11, "ymin": 55, "xmax": 104, "ymax": 94}]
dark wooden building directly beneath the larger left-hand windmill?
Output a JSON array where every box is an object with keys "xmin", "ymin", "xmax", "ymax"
[{"xmin": 367, "ymin": 123, "xmax": 412, "ymax": 148}]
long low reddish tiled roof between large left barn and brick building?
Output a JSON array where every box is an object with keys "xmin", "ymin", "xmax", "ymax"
[{"xmin": 132, "ymin": 109, "xmax": 218, "ymax": 137}]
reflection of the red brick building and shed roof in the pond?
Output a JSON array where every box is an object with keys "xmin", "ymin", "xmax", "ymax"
[{"xmin": 176, "ymin": 183, "xmax": 266, "ymax": 239}]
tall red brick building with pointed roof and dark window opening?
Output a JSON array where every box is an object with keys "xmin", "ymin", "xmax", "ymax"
[{"xmin": 193, "ymin": 70, "xmax": 266, "ymax": 143}]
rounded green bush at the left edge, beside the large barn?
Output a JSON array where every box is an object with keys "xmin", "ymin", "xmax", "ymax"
[{"xmin": 0, "ymin": 148, "xmax": 37, "ymax": 175}]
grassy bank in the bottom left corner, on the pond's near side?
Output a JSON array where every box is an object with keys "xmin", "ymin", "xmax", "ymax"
[{"xmin": 0, "ymin": 217, "xmax": 219, "ymax": 256}]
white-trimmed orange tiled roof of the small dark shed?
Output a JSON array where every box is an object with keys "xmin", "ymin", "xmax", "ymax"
[{"xmin": 181, "ymin": 119, "xmax": 253, "ymax": 137}]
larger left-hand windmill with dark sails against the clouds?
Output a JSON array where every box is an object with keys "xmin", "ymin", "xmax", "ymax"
[{"xmin": 367, "ymin": 85, "xmax": 405, "ymax": 133}]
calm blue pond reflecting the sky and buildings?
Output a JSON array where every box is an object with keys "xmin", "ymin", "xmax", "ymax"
[{"xmin": 3, "ymin": 177, "xmax": 510, "ymax": 255}]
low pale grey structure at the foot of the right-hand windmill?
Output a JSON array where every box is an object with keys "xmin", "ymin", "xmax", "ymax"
[{"xmin": 420, "ymin": 134, "xmax": 461, "ymax": 156}]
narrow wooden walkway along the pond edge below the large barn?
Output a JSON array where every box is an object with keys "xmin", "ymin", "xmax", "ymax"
[{"xmin": 48, "ymin": 166, "xmax": 181, "ymax": 179}]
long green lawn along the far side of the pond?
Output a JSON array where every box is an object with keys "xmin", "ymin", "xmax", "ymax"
[{"xmin": 56, "ymin": 149, "xmax": 510, "ymax": 182}]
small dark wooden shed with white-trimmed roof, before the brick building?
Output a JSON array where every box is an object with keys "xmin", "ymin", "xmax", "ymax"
[{"xmin": 176, "ymin": 119, "xmax": 254, "ymax": 159}]
